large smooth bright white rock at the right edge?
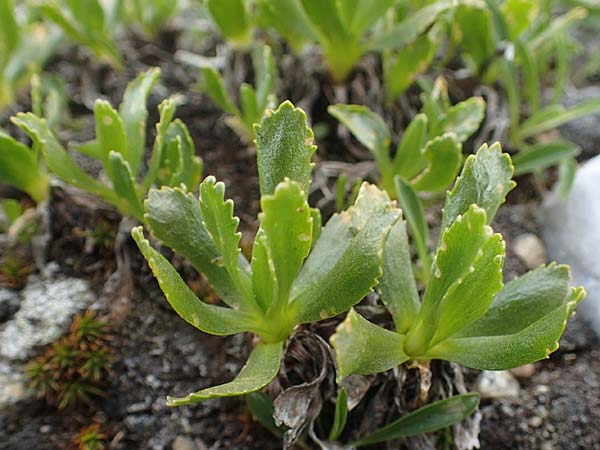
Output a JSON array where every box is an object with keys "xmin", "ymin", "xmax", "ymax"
[{"xmin": 541, "ymin": 156, "xmax": 600, "ymax": 336}]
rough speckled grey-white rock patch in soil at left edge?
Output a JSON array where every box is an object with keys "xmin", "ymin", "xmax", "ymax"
[{"xmin": 0, "ymin": 277, "xmax": 95, "ymax": 360}]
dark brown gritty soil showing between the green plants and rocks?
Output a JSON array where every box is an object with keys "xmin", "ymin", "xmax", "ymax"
[{"xmin": 0, "ymin": 19, "xmax": 600, "ymax": 450}]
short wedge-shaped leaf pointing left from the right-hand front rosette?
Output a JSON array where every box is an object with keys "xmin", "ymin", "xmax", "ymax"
[{"xmin": 330, "ymin": 309, "xmax": 409, "ymax": 379}]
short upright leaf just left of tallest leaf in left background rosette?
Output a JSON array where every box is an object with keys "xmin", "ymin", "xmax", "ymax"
[{"xmin": 94, "ymin": 100, "xmax": 127, "ymax": 172}]
